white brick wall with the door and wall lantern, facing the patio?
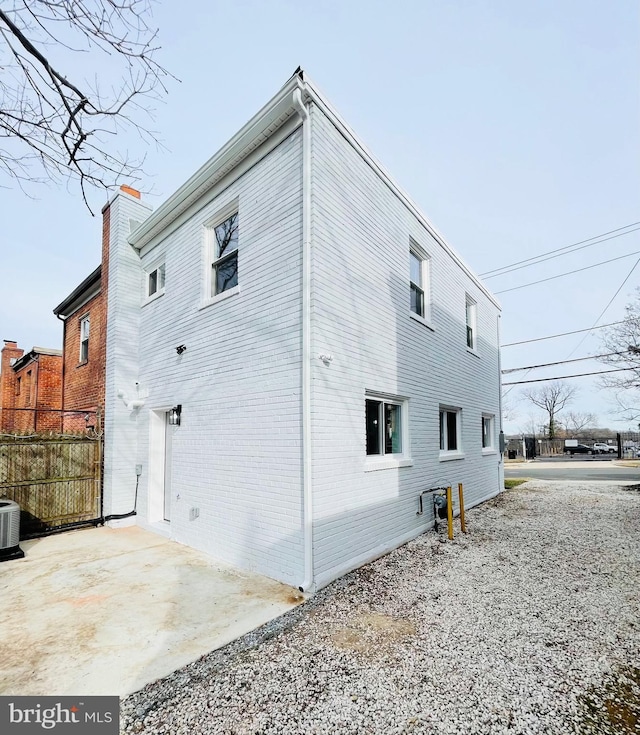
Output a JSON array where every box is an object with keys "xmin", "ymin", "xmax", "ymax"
[{"xmin": 109, "ymin": 130, "xmax": 303, "ymax": 584}]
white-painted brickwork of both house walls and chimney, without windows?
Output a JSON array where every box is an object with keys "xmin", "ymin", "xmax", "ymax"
[{"xmin": 105, "ymin": 96, "xmax": 502, "ymax": 586}]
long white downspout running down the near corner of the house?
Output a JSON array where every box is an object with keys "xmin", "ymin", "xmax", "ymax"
[{"xmin": 293, "ymin": 89, "xmax": 313, "ymax": 592}]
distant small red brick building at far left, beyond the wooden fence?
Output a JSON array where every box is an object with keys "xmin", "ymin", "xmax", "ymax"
[{"xmin": 0, "ymin": 340, "xmax": 62, "ymax": 434}]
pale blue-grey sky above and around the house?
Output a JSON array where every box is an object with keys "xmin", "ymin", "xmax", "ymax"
[{"xmin": 0, "ymin": 0, "xmax": 640, "ymax": 432}]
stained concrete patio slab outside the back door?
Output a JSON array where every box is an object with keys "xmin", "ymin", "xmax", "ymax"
[{"xmin": 0, "ymin": 527, "xmax": 303, "ymax": 696}]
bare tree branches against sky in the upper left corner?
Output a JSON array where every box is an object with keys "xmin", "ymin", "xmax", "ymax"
[{"xmin": 0, "ymin": 0, "xmax": 167, "ymax": 207}]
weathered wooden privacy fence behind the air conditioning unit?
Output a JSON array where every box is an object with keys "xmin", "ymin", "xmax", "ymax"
[{"xmin": 0, "ymin": 437, "xmax": 102, "ymax": 538}]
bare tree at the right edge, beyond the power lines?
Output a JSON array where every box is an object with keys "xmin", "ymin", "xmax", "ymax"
[{"xmin": 599, "ymin": 288, "xmax": 640, "ymax": 421}]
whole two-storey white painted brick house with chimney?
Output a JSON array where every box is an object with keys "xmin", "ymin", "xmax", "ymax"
[{"xmin": 104, "ymin": 70, "xmax": 503, "ymax": 590}]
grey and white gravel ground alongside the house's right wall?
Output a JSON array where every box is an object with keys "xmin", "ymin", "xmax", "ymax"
[{"xmin": 121, "ymin": 481, "xmax": 640, "ymax": 735}]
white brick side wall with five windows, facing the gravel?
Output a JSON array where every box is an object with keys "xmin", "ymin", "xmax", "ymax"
[{"xmin": 312, "ymin": 107, "xmax": 502, "ymax": 586}]
